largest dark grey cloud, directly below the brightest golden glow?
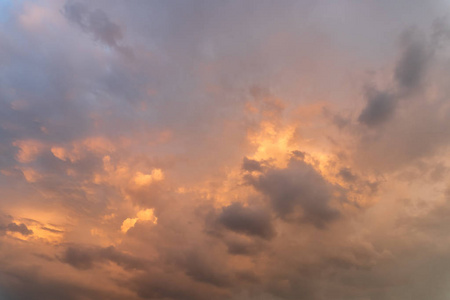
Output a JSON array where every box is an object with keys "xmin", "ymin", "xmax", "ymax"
[{"xmin": 247, "ymin": 159, "xmax": 340, "ymax": 228}]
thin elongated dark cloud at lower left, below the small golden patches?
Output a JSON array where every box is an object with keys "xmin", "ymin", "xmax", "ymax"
[{"xmin": 60, "ymin": 246, "xmax": 148, "ymax": 270}]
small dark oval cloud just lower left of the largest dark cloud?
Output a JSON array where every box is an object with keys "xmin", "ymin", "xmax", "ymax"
[{"xmin": 218, "ymin": 202, "xmax": 275, "ymax": 239}]
